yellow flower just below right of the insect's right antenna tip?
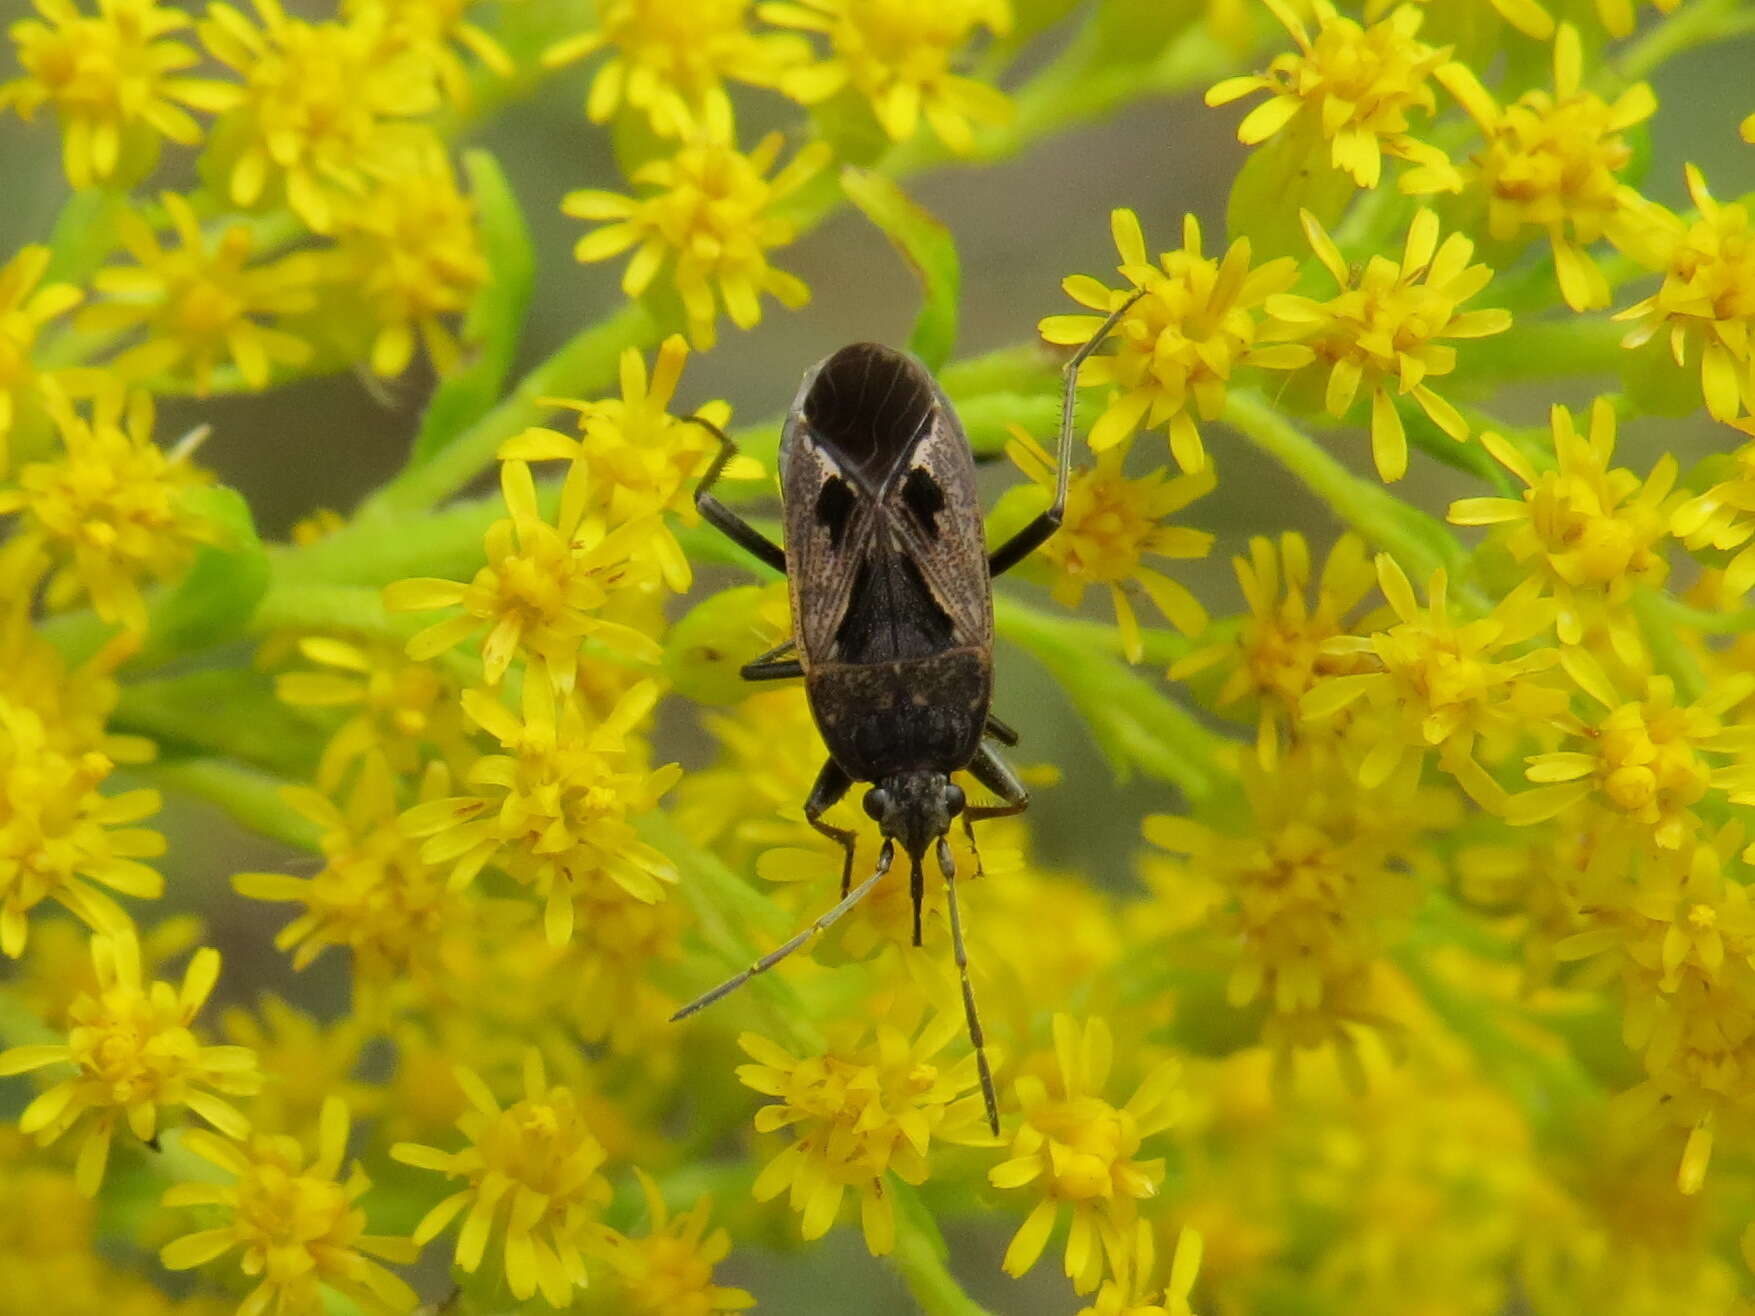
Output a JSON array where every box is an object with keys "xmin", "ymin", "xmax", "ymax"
[{"xmin": 988, "ymin": 1014, "xmax": 1183, "ymax": 1293}]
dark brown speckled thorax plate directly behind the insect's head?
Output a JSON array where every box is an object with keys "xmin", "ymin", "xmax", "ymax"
[{"xmin": 806, "ymin": 649, "xmax": 993, "ymax": 781}]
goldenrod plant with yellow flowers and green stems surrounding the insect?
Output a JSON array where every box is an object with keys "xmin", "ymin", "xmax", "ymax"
[{"xmin": 0, "ymin": 0, "xmax": 1755, "ymax": 1316}]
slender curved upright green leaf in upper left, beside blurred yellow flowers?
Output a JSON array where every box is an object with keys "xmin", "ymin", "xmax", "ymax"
[{"xmin": 409, "ymin": 151, "xmax": 535, "ymax": 467}]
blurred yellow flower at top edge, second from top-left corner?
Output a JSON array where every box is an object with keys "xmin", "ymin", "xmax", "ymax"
[{"xmin": 200, "ymin": 0, "xmax": 439, "ymax": 233}]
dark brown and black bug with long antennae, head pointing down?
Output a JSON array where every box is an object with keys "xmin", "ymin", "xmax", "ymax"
[{"xmin": 672, "ymin": 295, "xmax": 1137, "ymax": 1134}]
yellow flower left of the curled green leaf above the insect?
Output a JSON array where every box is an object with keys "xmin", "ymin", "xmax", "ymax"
[{"xmin": 562, "ymin": 133, "xmax": 830, "ymax": 351}]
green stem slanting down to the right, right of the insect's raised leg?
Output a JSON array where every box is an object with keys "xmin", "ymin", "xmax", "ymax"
[{"xmin": 1225, "ymin": 390, "xmax": 1490, "ymax": 612}]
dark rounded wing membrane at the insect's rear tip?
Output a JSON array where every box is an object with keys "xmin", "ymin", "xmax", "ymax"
[{"xmin": 804, "ymin": 342, "xmax": 934, "ymax": 490}]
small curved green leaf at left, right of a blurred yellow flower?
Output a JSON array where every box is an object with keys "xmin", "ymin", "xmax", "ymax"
[{"xmin": 137, "ymin": 484, "xmax": 270, "ymax": 665}]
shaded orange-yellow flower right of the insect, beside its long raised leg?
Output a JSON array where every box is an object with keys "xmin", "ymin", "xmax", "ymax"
[{"xmin": 1006, "ymin": 426, "xmax": 1218, "ymax": 663}]
